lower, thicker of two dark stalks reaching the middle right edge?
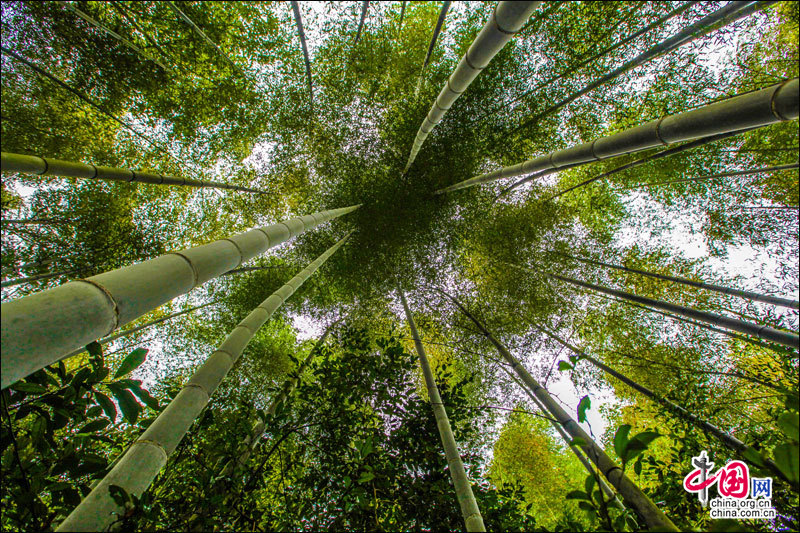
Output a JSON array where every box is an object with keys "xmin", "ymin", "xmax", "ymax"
[{"xmin": 552, "ymin": 269, "xmax": 800, "ymax": 349}]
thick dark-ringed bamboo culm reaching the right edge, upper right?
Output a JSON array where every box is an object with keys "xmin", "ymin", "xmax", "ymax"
[{"xmin": 436, "ymin": 78, "xmax": 800, "ymax": 194}]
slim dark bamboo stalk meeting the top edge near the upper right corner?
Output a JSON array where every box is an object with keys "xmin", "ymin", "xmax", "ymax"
[{"xmin": 509, "ymin": 1, "xmax": 774, "ymax": 139}]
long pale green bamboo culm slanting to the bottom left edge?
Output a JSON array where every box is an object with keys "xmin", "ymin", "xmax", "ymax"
[{"xmin": 56, "ymin": 234, "xmax": 350, "ymax": 531}]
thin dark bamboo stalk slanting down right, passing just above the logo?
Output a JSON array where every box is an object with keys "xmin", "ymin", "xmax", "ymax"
[{"xmin": 536, "ymin": 326, "xmax": 797, "ymax": 491}]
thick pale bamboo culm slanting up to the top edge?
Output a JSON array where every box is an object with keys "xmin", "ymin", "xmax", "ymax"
[{"xmin": 403, "ymin": 1, "xmax": 541, "ymax": 173}]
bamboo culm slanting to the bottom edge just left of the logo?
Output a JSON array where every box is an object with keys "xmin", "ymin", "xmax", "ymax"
[{"xmin": 439, "ymin": 290, "xmax": 678, "ymax": 531}]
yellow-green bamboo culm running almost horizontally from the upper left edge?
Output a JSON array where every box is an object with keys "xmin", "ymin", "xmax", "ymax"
[{"xmin": 0, "ymin": 152, "xmax": 267, "ymax": 194}]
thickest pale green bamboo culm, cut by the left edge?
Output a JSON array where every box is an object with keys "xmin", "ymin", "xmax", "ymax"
[{"xmin": 0, "ymin": 206, "xmax": 359, "ymax": 388}]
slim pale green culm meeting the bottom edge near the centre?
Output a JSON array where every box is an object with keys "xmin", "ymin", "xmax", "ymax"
[{"xmin": 398, "ymin": 290, "xmax": 486, "ymax": 531}]
